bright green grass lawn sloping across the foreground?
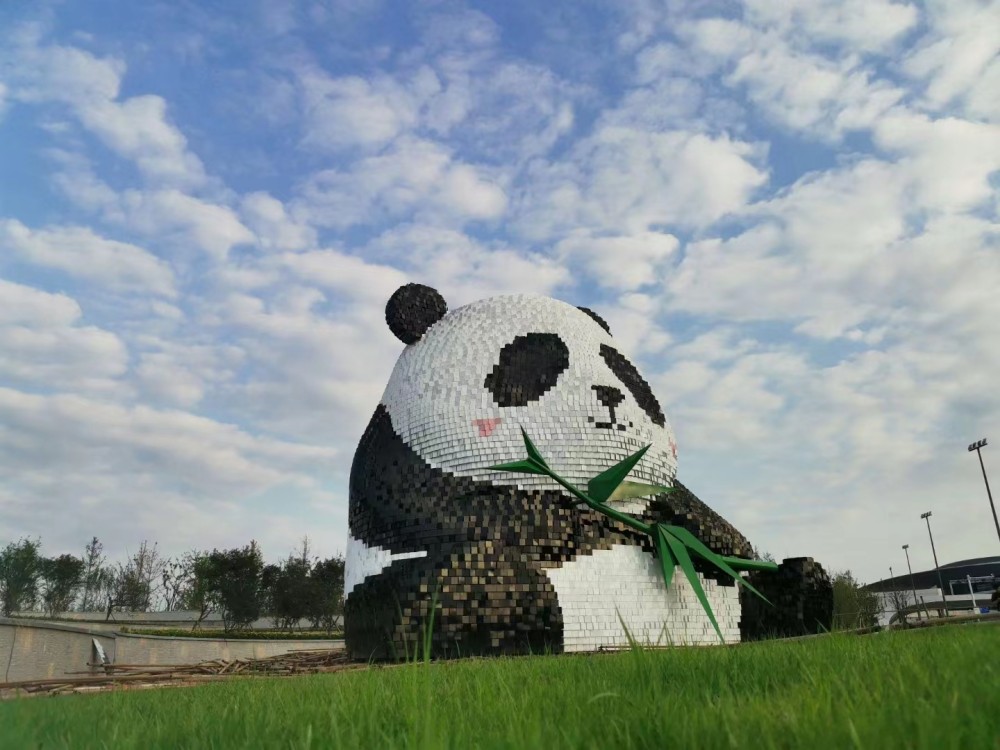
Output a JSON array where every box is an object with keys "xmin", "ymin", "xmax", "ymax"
[{"xmin": 0, "ymin": 625, "xmax": 1000, "ymax": 750}]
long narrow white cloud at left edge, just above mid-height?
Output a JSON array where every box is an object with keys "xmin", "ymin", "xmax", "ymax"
[{"xmin": 0, "ymin": 219, "xmax": 177, "ymax": 298}]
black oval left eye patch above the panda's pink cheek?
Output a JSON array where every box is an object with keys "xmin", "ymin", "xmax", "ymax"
[{"xmin": 483, "ymin": 333, "xmax": 569, "ymax": 406}]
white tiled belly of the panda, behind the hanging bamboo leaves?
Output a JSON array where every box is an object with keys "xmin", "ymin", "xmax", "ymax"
[{"xmin": 545, "ymin": 545, "xmax": 740, "ymax": 651}]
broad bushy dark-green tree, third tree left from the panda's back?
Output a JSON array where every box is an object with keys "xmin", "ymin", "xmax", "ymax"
[{"xmin": 203, "ymin": 541, "xmax": 264, "ymax": 631}]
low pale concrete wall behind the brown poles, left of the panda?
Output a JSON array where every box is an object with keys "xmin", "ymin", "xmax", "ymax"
[{"xmin": 0, "ymin": 618, "xmax": 344, "ymax": 682}]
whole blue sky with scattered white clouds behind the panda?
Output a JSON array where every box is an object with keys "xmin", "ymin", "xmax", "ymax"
[{"xmin": 0, "ymin": 0, "xmax": 1000, "ymax": 581}]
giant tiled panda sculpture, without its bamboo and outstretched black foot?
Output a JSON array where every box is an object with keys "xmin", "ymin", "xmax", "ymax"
[{"xmin": 344, "ymin": 284, "xmax": 752, "ymax": 659}]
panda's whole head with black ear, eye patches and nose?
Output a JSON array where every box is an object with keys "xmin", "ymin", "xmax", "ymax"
[{"xmin": 382, "ymin": 284, "xmax": 677, "ymax": 512}]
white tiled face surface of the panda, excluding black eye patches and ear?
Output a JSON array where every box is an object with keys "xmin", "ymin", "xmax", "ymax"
[{"xmin": 382, "ymin": 295, "xmax": 677, "ymax": 500}]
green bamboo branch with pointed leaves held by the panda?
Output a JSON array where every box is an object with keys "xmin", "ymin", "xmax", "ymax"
[{"xmin": 489, "ymin": 427, "xmax": 778, "ymax": 643}]
